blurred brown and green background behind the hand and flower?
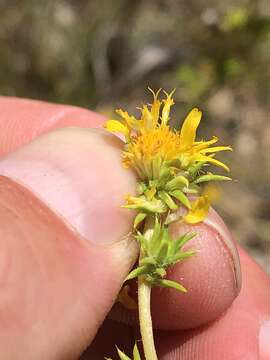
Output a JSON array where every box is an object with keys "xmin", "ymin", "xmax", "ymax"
[{"xmin": 0, "ymin": 0, "xmax": 270, "ymax": 273}]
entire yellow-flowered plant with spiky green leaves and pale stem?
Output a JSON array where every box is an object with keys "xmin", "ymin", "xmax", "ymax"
[{"xmin": 105, "ymin": 89, "xmax": 231, "ymax": 360}]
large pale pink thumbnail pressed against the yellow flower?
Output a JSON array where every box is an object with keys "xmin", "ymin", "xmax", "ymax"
[{"xmin": 0, "ymin": 128, "xmax": 135, "ymax": 244}]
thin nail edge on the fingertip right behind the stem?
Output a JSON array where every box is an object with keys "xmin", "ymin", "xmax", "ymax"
[{"xmin": 204, "ymin": 209, "xmax": 242, "ymax": 294}]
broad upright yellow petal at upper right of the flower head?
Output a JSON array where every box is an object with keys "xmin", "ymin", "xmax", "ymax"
[{"xmin": 180, "ymin": 108, "xmax": 202, "ymax": 149}]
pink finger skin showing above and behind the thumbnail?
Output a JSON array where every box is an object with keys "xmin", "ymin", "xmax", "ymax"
[{"xmin": 0, "ymin": 97, "xmax": 104, "ymax": 156}]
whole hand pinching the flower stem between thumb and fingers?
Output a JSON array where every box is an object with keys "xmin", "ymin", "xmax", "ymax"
[{"xmin": 0, "ymin": 98, "xmax": 270, "ymax": 360}]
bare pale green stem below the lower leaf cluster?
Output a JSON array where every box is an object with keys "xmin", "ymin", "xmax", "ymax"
[{"xmin": 138, "ymin": 270, "xmax": 158, "ymax": 360}]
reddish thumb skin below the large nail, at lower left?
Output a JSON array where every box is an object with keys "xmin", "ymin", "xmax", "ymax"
[{"xmin": 0, "ymin": 176, "xmax": 135, "ymax": 360}]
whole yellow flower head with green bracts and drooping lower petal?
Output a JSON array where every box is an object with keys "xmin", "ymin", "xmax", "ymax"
[{"xmin": 105, "ymin": 90, "xmax": 231, "ymax": 223}]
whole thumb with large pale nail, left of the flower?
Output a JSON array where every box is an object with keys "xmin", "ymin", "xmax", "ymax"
[{"xmin": 0, "ymin": 128, "xmax": 137, "ymax": 360}]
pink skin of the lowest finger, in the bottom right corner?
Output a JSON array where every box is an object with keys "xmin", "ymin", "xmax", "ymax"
[{"xmin": 156, "ymin": 250, "xmax": 270, "ymax": 360}]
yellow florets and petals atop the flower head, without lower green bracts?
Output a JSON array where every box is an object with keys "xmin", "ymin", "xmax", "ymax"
[{"xmin": 105, "ymin": 90, "xmax": 231, "ymax": 180}]
